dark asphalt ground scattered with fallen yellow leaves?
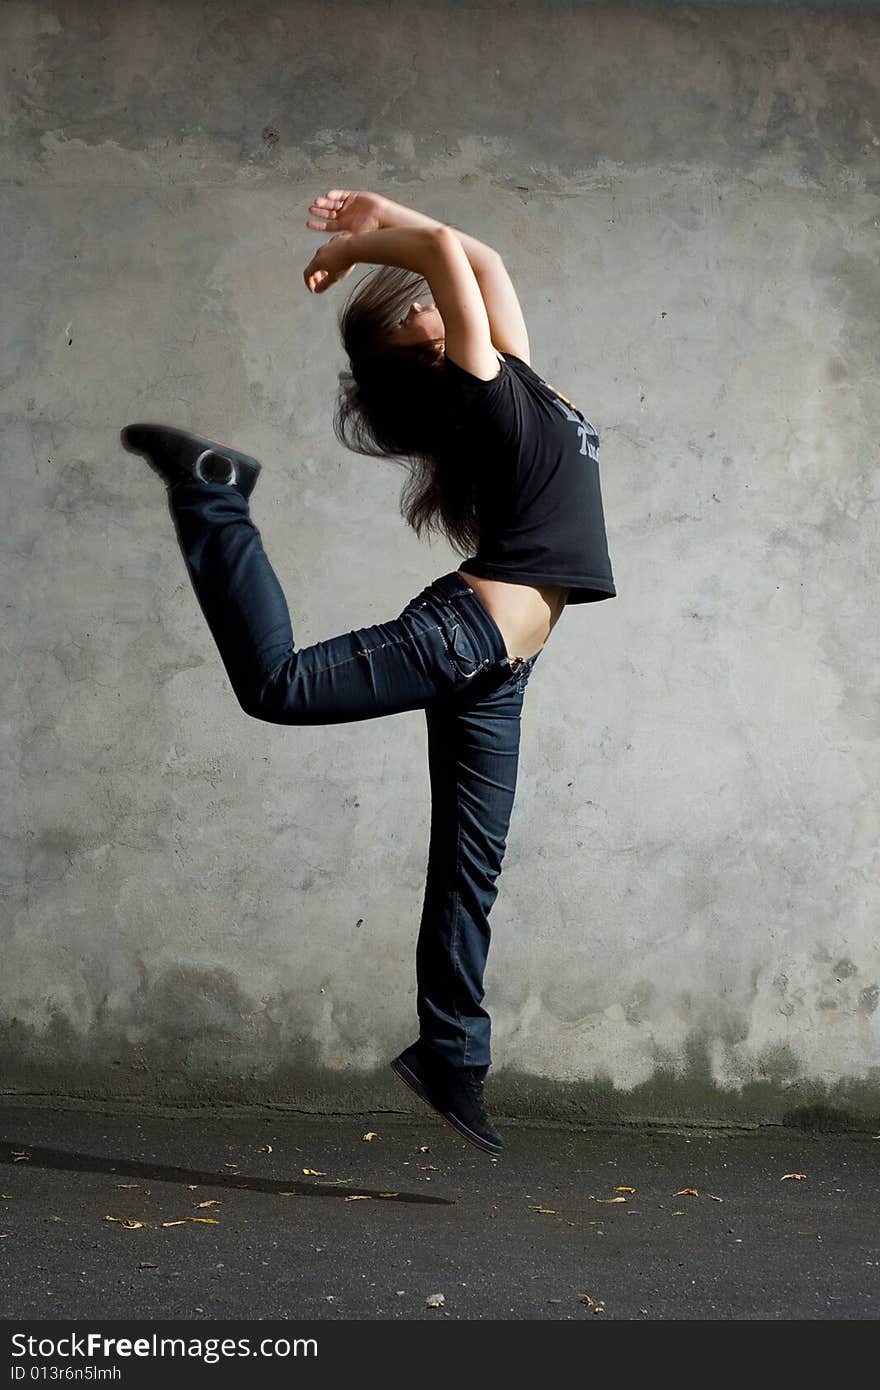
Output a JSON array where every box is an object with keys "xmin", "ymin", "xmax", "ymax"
[{"xmin": 0, "ymin": 1097, "xmax": 880, "ymax": 1325}]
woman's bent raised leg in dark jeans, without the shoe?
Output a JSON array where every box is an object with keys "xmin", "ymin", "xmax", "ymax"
[{"xmin": 168, "ymin": 482, "xmax": 510, "ymax": 724}]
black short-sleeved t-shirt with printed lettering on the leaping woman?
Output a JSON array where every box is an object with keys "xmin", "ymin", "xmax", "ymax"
[{"xmin": 445, "ymin": 352, "xmax": 617, "ymax": 603}]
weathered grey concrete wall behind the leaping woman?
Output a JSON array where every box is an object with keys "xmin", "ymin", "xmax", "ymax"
[{"xmin": 0, "ymin": 0, "xmax": 880, "ymax": 1123}]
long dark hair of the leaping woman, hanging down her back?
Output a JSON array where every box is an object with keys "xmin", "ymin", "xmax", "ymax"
[{"xmin": 334, "ymin": 265, "xmax": 480, "ymax": 555}]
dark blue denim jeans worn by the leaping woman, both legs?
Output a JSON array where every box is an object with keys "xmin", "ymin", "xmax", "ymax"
[{"xmin": 168, "ymin": 482, "xmax": 539, "ymax": 1066}]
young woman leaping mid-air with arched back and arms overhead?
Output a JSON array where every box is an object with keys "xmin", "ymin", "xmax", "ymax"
[{"xmin": 122, "ymin": 189, "xmax": 616, "ymax": 1154}]
